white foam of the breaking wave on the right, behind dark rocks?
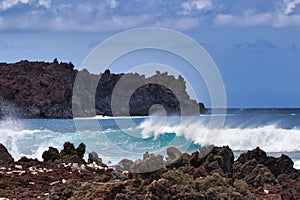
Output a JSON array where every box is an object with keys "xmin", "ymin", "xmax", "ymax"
[{"xmin": 139, "ymin": 118, "xmax": 300, "ymax": 152}]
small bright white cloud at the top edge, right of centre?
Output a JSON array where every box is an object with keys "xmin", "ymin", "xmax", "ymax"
[{"xmin": 181, "ymin": 0, "xmax": 213, "ymax": 15}]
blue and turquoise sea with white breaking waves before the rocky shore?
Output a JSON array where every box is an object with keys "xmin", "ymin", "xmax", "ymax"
[{"xmin": 0, "ymin": 109, "xmax": 300, "ymax": 168}]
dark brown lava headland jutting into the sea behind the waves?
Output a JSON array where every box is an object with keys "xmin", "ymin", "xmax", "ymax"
[{"xmin": 0, "ymin": 61, "xmax": 205, "ymax": 118}]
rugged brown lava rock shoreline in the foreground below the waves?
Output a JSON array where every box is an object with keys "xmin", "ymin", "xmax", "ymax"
[{"xmin": 0, "ymin": 142, "xmax": 300, "ymax": 200}]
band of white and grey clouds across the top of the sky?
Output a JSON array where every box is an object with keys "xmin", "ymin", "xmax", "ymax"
[{"xmin": 0, "ymin": 0, "xmax": 300, "ymax": 32}]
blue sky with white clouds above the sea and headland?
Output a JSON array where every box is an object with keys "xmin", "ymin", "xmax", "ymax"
[{"xmin": 0, "ymin": 0, "xmax": 300, "ymax": 108}]
